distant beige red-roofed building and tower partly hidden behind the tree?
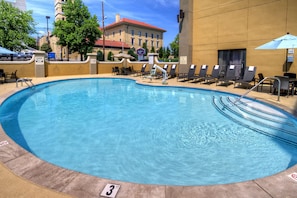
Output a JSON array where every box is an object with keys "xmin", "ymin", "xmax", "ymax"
[{"xmin": 46, "ymin": 0, "xmax": 166, "ymax": 59}]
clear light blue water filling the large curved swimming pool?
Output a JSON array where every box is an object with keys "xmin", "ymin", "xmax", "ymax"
[{"xmin": 0, "ymin": 78, "xmax": 297, "ymax": 185}]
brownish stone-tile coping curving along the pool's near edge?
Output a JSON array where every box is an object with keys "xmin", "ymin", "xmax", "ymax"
[{"xmin": 0, "ymin": 75, "xmax": 297, "ymax": 198}]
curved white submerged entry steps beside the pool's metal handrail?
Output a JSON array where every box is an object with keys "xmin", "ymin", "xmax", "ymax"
[{"xmin": 213, "ymin": 96, "xmax": 297, "ymax": 146}]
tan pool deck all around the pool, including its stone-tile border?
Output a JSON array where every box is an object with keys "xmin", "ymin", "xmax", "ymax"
[{"xmin": 0, "ymin": 75, "xmax": 297, "ymax": 198}]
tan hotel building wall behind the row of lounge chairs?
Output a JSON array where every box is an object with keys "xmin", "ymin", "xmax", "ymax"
[{"xmin": 179, "ymin": 0, "xmax": 297, "ymax": 76}]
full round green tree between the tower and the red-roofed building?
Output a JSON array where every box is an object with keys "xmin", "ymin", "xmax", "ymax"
[{"xmin": 53, "ymin": 0, "xmax": 101, "ymax": 60}]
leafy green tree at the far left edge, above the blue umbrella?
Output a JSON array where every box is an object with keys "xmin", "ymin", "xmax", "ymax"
[{"xmin": 0, "ymin": 0, "xmax": 36, "ymax": 51}]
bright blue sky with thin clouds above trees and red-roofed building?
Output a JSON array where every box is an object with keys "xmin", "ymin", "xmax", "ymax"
[{"xmin": 26, "ymin": 0, "xmax": 179, "ymax": 47}]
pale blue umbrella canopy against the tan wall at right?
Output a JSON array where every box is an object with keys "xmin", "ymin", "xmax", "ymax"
[{"xmin": 256, "ymin": 33, "xmax": 297, "ymax": 50}]
